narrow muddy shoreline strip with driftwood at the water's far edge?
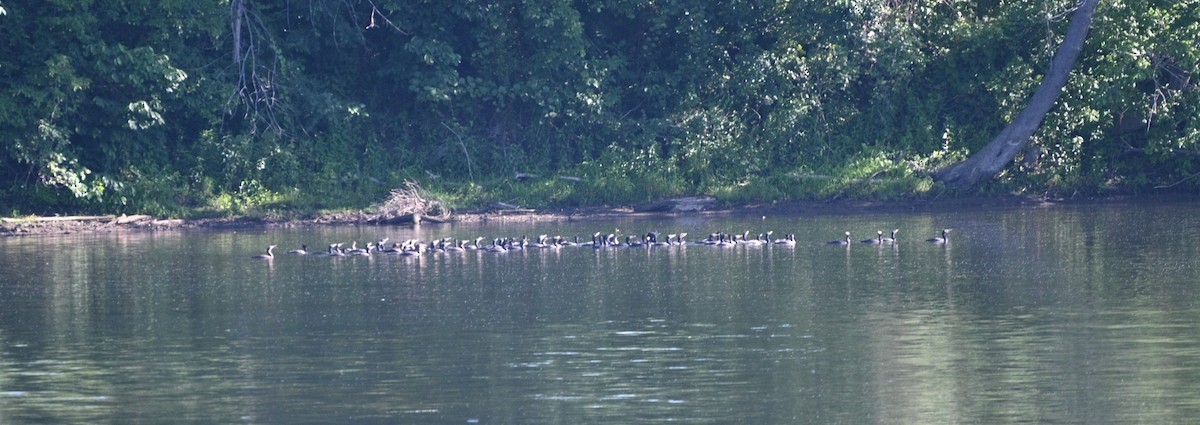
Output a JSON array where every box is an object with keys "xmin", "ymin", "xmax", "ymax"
[{"xmin": 0, "ymin": 194, "xmax": 1200, "ymax": 237}]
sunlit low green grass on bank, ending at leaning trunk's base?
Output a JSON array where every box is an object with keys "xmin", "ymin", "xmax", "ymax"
[{"xmin": 193, "ymin": 152, "xmax": 946, "ymax": 217}]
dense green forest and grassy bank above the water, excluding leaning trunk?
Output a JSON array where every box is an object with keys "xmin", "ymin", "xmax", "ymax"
[{"xmin": 0, "ymin": 0, "xmax": 1200, "ymax": 216}]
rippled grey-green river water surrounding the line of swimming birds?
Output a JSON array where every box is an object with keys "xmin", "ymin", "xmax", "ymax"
[{"xmin": 0, "ymin": 204, "xmax": 1200, "ymax": 424}]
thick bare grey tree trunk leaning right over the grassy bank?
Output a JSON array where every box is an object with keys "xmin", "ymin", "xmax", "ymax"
[{"xmin": 934, "ymin": 0, "xmax": 1099, "ymax": 187}]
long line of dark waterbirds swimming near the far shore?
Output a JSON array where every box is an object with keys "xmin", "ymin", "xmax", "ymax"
[{"xmin": 252, "ymin": 228, "xmax": 953, "ymax": 259}]
